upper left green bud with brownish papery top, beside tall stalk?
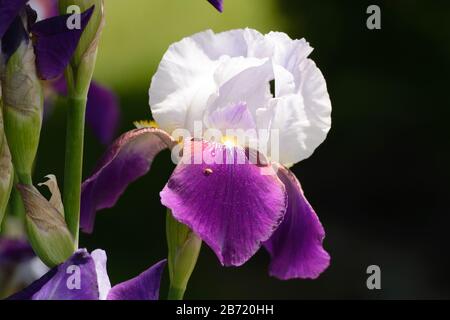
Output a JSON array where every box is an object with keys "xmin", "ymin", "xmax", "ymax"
[{"xmin": 0, "ymin": 41, "xmax": 43, "ymax": 184}]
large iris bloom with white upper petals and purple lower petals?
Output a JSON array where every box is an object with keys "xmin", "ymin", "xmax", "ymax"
[{"xmin": 81, "ymin": 29, "xmax": 331, "ymax": 279}]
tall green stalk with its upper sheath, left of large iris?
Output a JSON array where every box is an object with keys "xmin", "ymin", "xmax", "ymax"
[{"xmin": 59, "ymin": 0, "xmax": 104, "ymax": 249}]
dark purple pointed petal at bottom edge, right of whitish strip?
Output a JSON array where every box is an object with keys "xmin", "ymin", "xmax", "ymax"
[{"xmin": 108, "ymin": 260, "xmax": 167, "ymax": 300}]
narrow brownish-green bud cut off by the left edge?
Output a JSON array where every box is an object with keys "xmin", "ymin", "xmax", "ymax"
[{"xmin": 0, "ymin": 94, "xmax": 14, "ymax": 226}]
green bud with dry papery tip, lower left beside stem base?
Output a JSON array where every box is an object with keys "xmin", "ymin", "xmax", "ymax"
[{"xmin": 17, "ymin": 184, "xmax": 75, "ymax": 267}]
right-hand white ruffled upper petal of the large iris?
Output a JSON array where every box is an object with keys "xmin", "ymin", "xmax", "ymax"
[{"xmin": 260, "ymin": 32, "xmax": 331, "ymax": 165}]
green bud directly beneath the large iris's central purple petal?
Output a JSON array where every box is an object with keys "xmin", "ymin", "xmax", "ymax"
[{"xmin": 166, "ymin": 210, "xmax": 202, "ymax": 300}]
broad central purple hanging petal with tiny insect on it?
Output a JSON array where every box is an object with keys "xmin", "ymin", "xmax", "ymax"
[{"xmin": 161, "ymin": 141, "xmax": 287, "ymax": 266}]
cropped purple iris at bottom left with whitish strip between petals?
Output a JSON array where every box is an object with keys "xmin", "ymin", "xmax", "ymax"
[{"xmin": 9, "ymin": 249, "xmax": 166, "ymax": 300}]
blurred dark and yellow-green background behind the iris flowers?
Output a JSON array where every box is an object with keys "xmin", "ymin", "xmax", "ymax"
[{"xmin": 36, "ymin": 0, "xmax": 450, "ymax": 299}]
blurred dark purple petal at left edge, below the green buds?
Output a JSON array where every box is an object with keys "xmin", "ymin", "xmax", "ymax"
[{"xmin": 0, "ymin": 238, "xmax": 35, "ymax": 268}]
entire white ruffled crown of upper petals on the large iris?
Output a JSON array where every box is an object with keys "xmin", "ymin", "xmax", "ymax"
[{"xmin": 150, "ymin": 29, "xmax": 331, "ymax": 165}]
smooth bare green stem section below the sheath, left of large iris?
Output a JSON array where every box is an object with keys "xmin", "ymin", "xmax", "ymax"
[{"xmin": 63, "ymin": 98, "xmax": 87, "ymax": 249}]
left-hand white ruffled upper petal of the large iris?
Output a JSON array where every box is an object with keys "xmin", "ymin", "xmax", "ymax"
[{"xmin": 149, "ymin": 29, "xmax": 264, "ymax": 133}]
